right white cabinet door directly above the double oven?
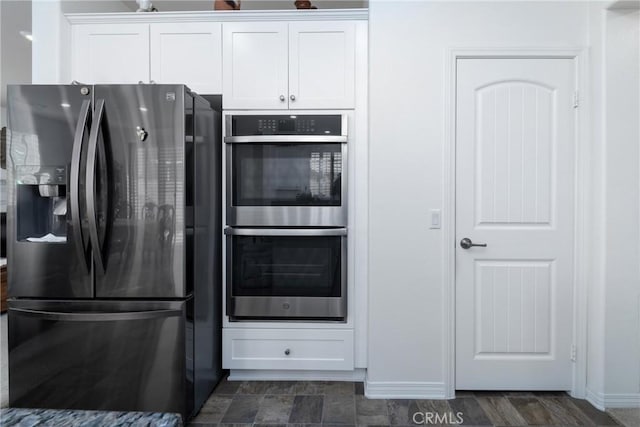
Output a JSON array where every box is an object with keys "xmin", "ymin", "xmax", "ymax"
[{"xmin": 289, "ymin": 22, "xmax": 355, "ymax": 109}]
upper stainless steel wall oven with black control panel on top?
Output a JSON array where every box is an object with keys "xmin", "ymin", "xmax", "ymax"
[{"xmin": 225, "ymin": 114, "xmax": 348, "ymax": 227}]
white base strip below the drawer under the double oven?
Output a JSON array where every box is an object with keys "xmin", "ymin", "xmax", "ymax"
[{"xmin": 228, "ymin": 369, "xmax": 366, "ymax": 381}]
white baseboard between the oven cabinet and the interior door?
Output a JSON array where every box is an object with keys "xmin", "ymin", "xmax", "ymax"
[{"xmin": 364, "ymin": 379, "xmax": 447, "ymax": 399}]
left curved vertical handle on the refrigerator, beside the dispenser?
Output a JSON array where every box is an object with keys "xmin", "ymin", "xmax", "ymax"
[{"xmin": 69, "ymin": 100, "xmax": 91, "ymax": 273}]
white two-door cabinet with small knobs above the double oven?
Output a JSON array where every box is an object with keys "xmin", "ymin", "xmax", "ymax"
[{"xmin": 222, "ymin": 21, "xmax": 355, "ymax": 109}]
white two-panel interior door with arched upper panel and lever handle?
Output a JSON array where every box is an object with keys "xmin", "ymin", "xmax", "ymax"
[{"xmin": 456, "ymin": 58, "xmax": 576, "ymax": 390}]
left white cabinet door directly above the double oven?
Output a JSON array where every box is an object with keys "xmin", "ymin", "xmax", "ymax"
[{"xmin": 222, "ymin": 22, "xmax": 288, "ymax": 109}]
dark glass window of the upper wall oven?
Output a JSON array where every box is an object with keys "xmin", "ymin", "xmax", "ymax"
[{"xmin": 232, "ymin": 143, "xmax": 342, "ymax": 206}]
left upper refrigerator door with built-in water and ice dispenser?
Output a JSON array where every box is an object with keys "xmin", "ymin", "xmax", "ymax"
[{"xmin": 7, "ymin": 85, "xmax": 93, "ymax": 298}]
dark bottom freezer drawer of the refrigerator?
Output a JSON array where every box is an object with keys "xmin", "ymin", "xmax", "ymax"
[{"xmin": 9, "ymin": 300, "xmax": 193, "ymax": 416}]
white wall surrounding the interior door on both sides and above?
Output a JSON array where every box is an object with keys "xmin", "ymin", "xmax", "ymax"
[{"xmin": 368, "ymin": 0, "xmax": 640, "ymax": 407}]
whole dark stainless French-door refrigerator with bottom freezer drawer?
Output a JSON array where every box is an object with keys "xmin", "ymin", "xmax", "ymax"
[{"xmin": 7, "ymin": 84, "xmax": 222, "ymax": 418}]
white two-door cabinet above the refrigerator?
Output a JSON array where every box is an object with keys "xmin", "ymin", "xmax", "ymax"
[{"xmin": 72, "ymin": 22, "xmax": 222, "ymax": 94}]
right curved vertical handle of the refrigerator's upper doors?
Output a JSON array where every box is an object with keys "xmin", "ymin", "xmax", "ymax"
[{"xmin": 85, "ymin": 99, "xmax": 105, "ymax": 274}]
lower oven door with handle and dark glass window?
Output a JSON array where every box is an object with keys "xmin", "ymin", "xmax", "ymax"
[{"xmin": 225, "ymin": 228, "xmax": 347, "ymax": 321}]
